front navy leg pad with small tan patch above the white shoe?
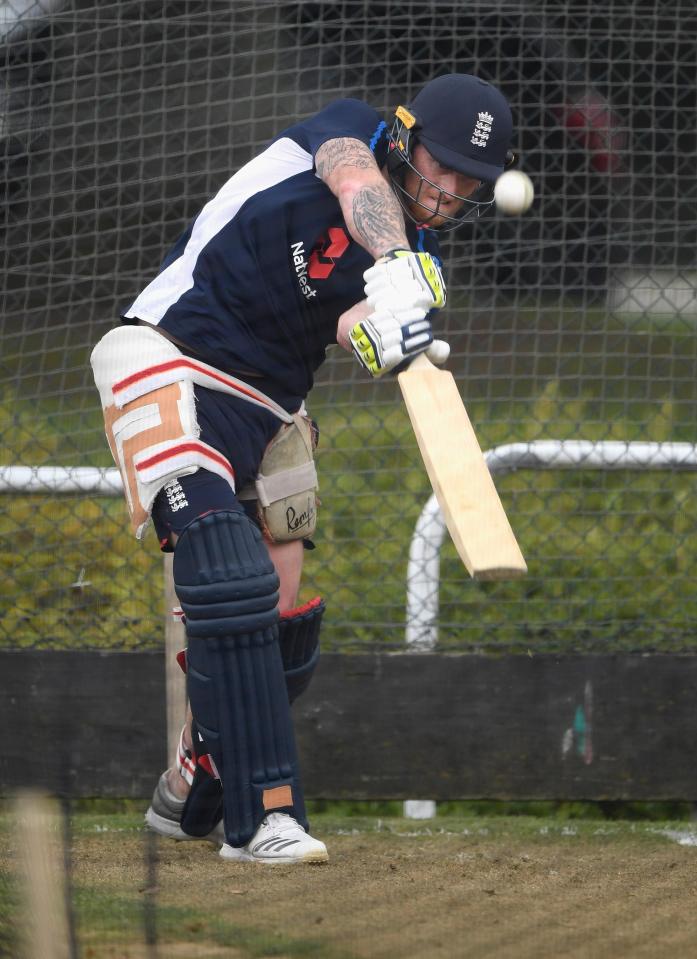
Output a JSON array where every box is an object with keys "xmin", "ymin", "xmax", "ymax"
[{"xmin": 174, "ymin": 511, "xmax": 306, "ymax": 846}]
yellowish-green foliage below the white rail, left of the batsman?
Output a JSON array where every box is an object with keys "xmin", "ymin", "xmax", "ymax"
[{"xmin": 0, "ymin": 495, "xmax": 163, "ymax": 649}]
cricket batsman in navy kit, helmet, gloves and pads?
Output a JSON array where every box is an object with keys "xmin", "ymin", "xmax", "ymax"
[{"xmin": 91, "ymin": 74, "xmax": 512, "ymax": 863}]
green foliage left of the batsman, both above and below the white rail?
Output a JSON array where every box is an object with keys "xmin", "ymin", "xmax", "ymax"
[{"xmin": 0, "ymin": 386, "xmax": 163, "ymax": 649}]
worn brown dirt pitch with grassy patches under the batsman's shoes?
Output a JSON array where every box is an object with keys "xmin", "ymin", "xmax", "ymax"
[{"xmin": 0, "ymin": 814, "xmax": 697, "ymax": 959}]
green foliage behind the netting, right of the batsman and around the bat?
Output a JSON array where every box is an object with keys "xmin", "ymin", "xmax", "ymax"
[{"xmin": 307, "ymin": 380, "xmax": 697, "ymax": 653}]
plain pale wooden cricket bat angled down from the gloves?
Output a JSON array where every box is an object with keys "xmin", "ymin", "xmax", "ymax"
[{"xmin": 397, "ymin": 353, "xmax": 528, "ymax": 579}]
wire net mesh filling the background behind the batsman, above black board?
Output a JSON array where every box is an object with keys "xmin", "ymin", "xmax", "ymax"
[{"xmin": 0, "ymin": 0, "xmax": 697, "ymax": 651}]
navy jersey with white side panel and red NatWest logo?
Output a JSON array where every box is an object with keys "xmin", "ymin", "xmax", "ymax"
[{"xmin": 122, "ymin": 99, "xmax": 438, "ymax": 409}]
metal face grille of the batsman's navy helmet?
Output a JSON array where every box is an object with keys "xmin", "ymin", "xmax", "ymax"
[{"xmin": 387, "ymin": 118, "xmax": 494, "ymax": 233}]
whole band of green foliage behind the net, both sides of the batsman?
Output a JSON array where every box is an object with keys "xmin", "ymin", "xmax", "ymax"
[{"xmin": 0, "ymin": 310, "xmax": 697, "ymax": 655}]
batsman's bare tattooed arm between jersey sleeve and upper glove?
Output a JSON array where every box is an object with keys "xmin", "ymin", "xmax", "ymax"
[{"xmin": 315, "ymin": 137, "xmax": 409, "ymax": 259}]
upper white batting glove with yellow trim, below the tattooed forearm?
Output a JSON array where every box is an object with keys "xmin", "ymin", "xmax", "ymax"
[{"xmin": 363, "ymin": 250, "xmax": 446, "ymax": 310}]
